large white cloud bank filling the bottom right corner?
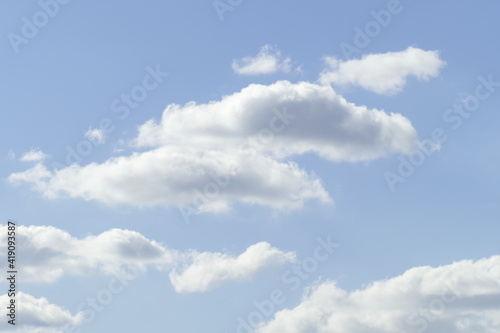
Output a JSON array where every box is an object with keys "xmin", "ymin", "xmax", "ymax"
[{"xmin": 256, "ymin": 256, "xmax": 500, "ymax": 333}]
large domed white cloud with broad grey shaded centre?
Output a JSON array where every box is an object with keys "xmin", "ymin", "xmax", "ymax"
[{"xmin": 136, "ymin": 81, "xmax": 418, "ymax": 162}]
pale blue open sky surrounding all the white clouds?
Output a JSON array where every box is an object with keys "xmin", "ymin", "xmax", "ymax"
[{"xmin": 0, "ymin": 0, "xmax": 500, "ymax": 333}]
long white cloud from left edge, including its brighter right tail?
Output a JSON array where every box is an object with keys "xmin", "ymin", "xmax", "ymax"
[{"xmin": 0, "ymin": 226, "xmax": 295, "ymax": 292}]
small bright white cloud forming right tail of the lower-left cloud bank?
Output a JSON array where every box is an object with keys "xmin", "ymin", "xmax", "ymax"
[{"xmin": 170, "ymin": 242, "xmax": 295, "ymax": 292}]
